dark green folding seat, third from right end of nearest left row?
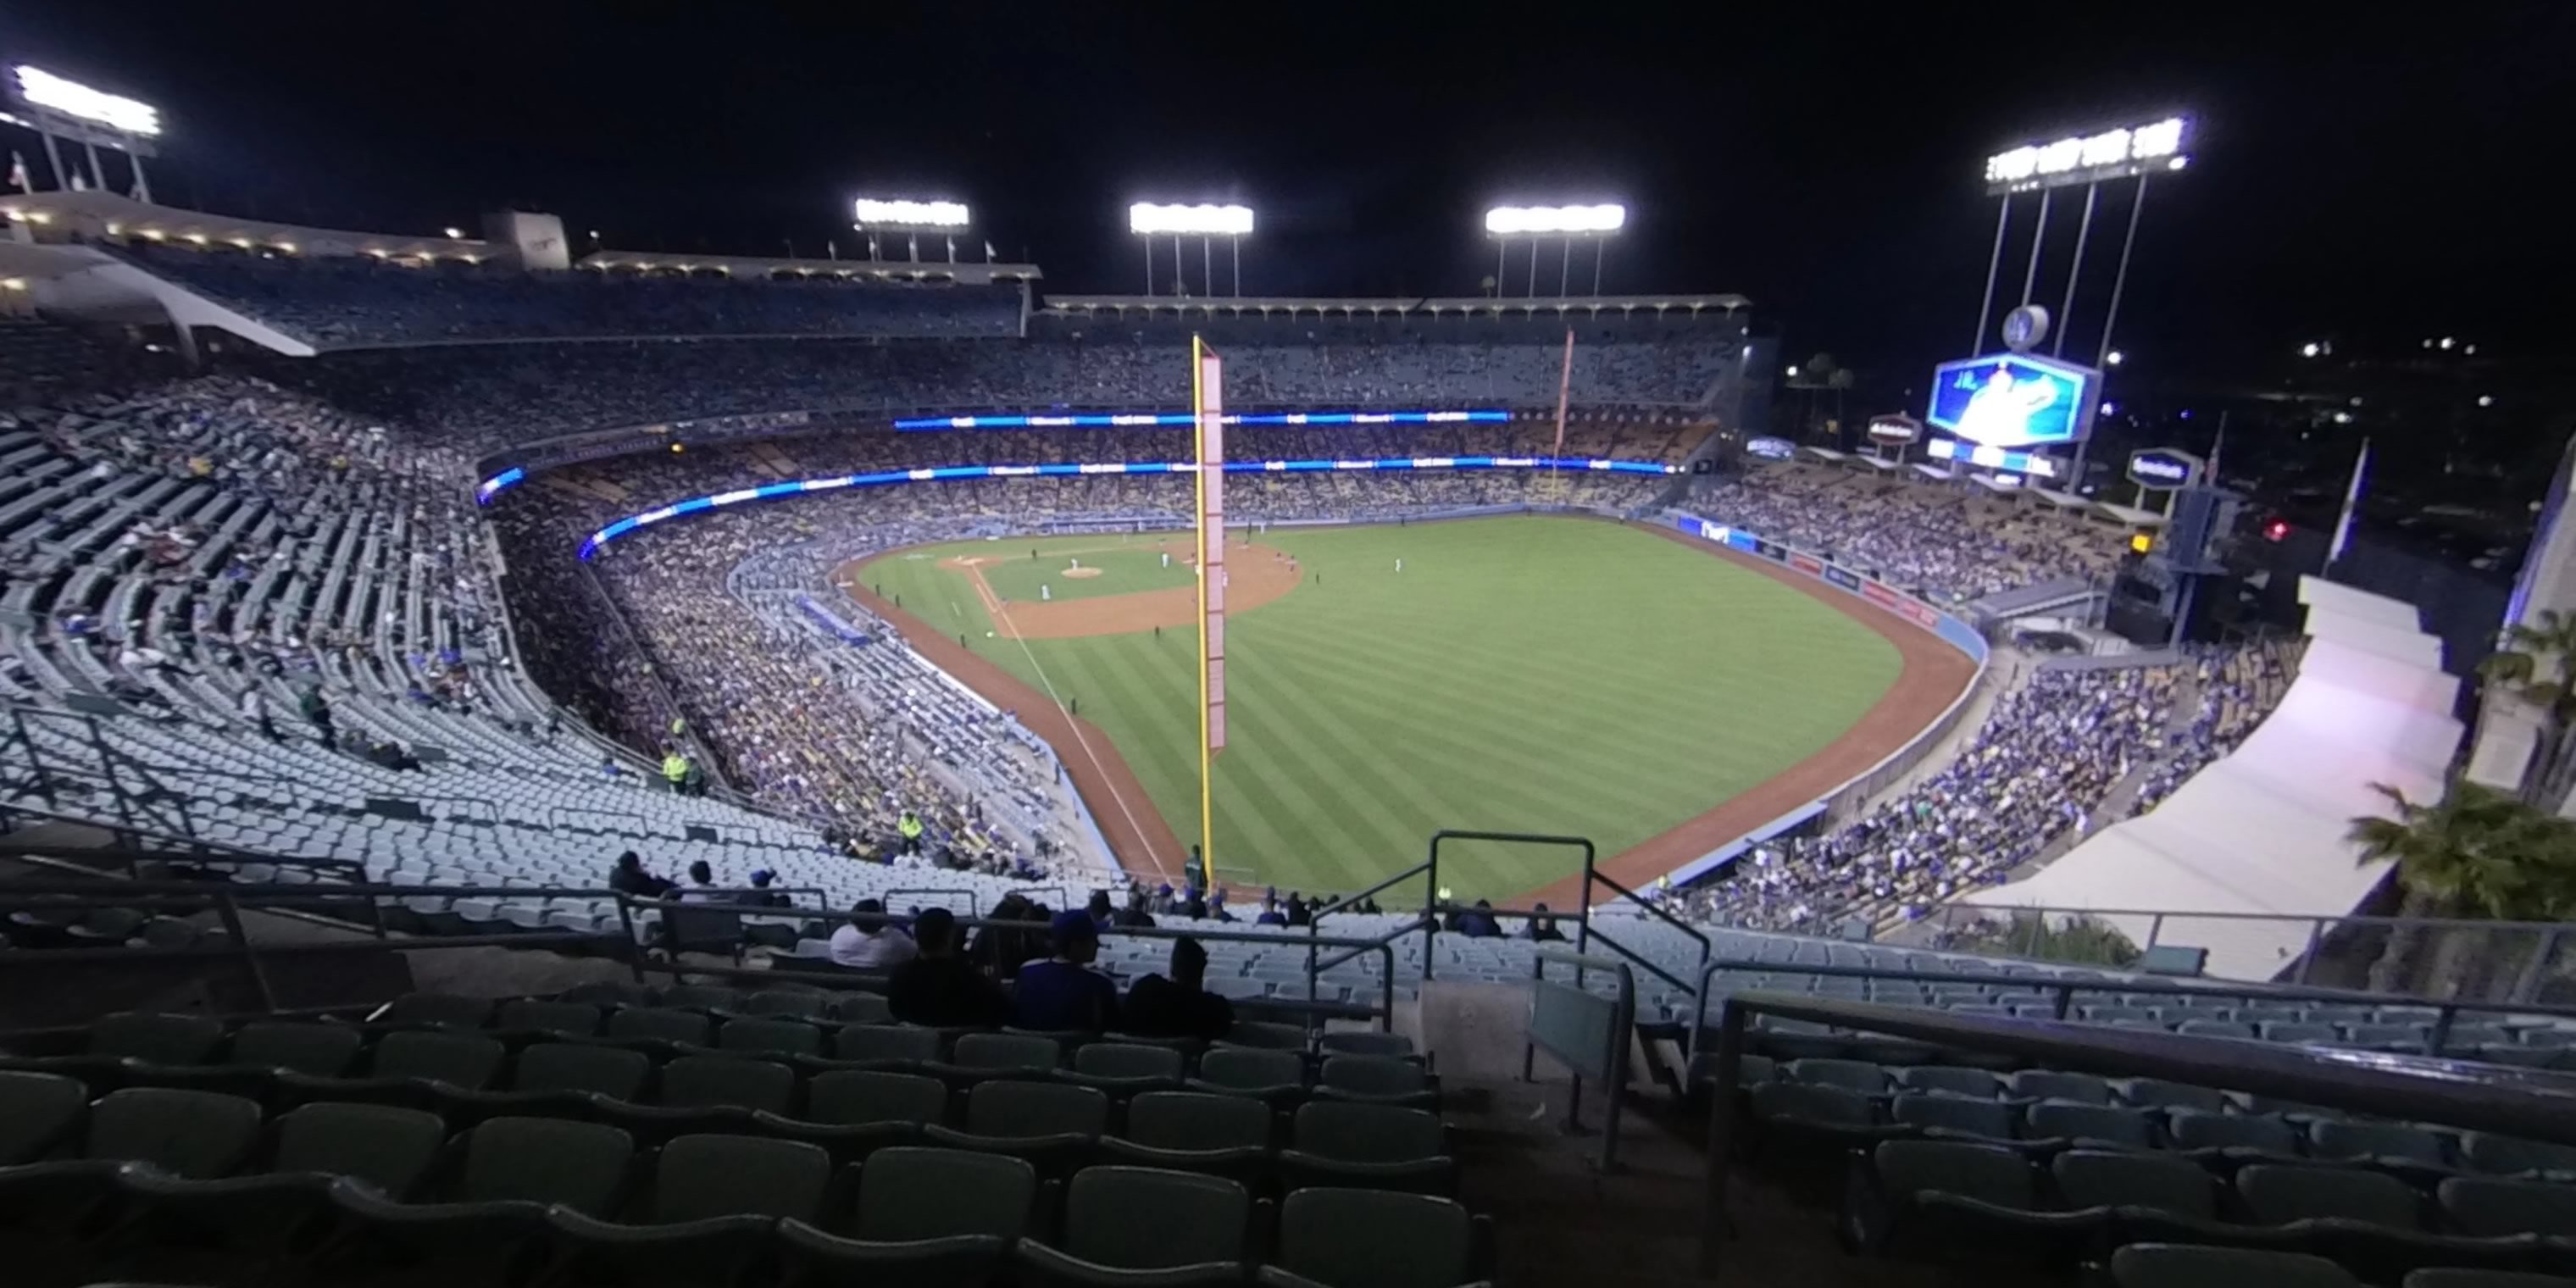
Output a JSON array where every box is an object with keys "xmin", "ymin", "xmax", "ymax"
[{"xmin": 778, "ymin": 1146, "xmax": 1038, "ymax": 1288}]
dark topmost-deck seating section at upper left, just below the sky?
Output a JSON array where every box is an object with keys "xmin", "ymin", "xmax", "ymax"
[{"xmin": 119, "ymin": 242, "xmax": 1020, "ymax": 347}]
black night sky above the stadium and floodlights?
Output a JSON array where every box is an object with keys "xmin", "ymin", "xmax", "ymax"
[{"xmin": 0, "ymin": 0, "xmax": 2576, "ymax": 379}]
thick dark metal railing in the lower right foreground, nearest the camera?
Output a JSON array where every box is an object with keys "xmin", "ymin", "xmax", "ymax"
[{"xmin": 1700, "ymin": 991, "xmax": 2576, "ymax": 1275}]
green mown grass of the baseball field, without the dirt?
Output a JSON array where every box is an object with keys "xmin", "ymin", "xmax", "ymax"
[{"xmin": 865, "ymin": 515, "xmax": 1901, "ymax": 899}]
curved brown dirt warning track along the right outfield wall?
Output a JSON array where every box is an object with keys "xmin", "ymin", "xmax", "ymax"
[{"xmin": 1512, "ymin": 523, "xmax": 1976, "ymax": 907}]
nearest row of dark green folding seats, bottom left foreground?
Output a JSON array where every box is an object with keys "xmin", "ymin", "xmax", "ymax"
[{"xmin": 0, "ymin": 1074, "xmax": 1484, "ymax": 1288}]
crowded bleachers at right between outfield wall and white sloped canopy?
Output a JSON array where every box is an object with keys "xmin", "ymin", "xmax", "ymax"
[{"xmin": 1677, "ymin": 667, "xmax": 2187, "ymax": 932}]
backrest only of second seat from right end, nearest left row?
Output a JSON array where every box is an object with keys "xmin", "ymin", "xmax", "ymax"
[{"xmin": 1064, "ymin": 1167, "xmax": 1252, "ymax": 1270}]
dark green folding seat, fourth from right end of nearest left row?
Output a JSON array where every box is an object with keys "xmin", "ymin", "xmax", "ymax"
[{"xmin": 546, "ymin": 1136, "xmax": 832, "ymax": 1285}]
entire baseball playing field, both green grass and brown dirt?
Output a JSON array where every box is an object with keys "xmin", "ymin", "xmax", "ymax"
[{"xmin": 832, "ymin": 515, "xmax": 1976, "ymax": 907}]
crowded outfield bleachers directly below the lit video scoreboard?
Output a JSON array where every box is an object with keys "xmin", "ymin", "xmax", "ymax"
[{"xmin": 1685, "ymin": 464, "xmax": 2120, "ymax": 602}]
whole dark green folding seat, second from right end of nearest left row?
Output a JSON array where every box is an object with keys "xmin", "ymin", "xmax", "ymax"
[{"xmin": 1013, "ymin": 1167, "xmax": 1252, "ymax": 1288}]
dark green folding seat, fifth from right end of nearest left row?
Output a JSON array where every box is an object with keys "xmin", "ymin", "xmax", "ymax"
[{"xmin": 314, "ymin": 1118, "xmax": 634, "ymax": 1283}]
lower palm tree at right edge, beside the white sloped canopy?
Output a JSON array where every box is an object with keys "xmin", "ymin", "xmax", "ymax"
[{"xmin": 2346, "ymin": 778, "xmax": 2576, "ymax": 994}]
